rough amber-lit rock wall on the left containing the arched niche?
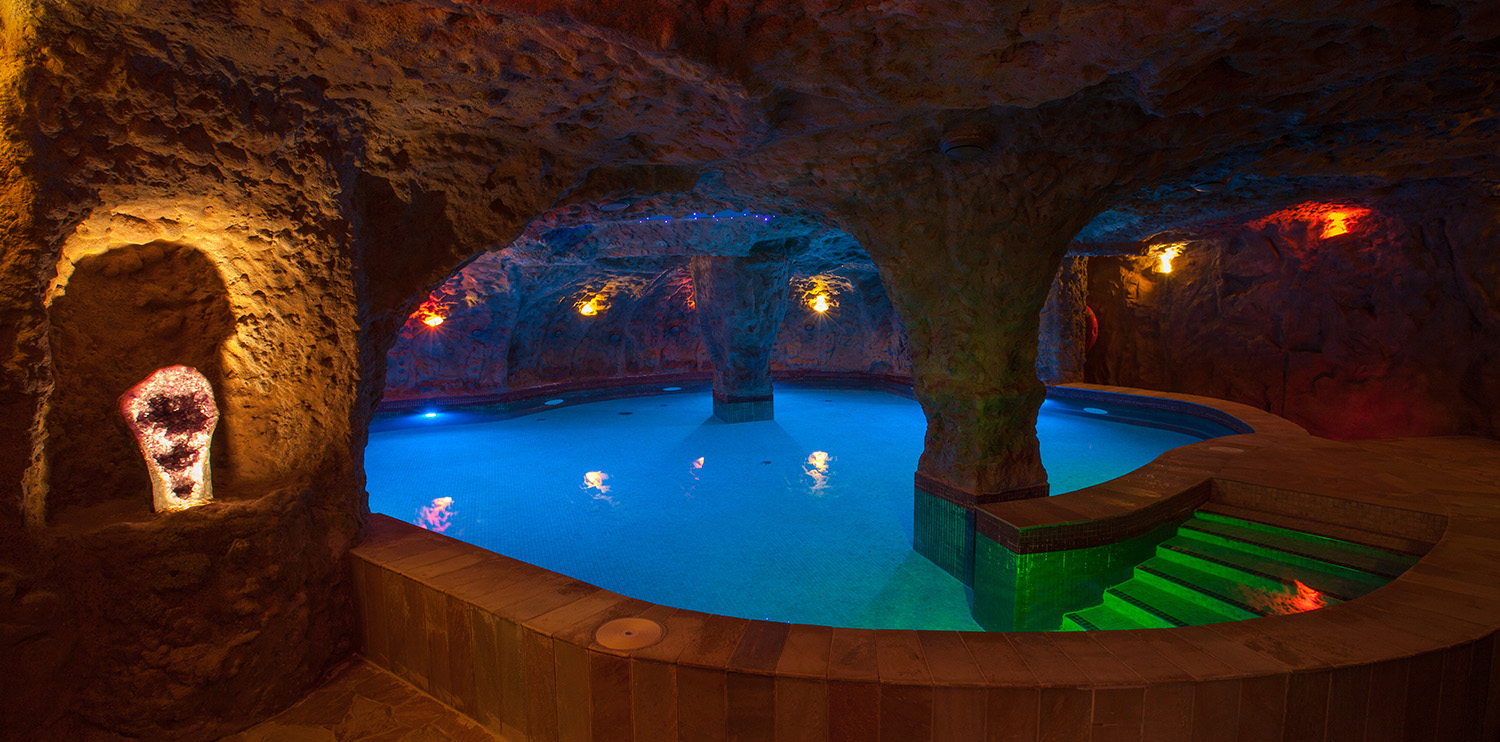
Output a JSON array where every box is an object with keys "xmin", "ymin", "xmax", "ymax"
[{"xmin": 0, "ymin": 7, "xmax": 363, "ymax": 739}]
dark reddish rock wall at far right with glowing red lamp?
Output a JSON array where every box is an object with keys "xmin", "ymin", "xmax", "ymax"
[{"xmin": 1086, "ymin": 183, "xmax": 1500, "ymax": 439}]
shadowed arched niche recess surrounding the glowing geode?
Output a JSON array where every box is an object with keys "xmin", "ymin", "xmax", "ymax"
[{"xmin": 47, "ymin": 241, "xmax": 234, "ymax": 514}]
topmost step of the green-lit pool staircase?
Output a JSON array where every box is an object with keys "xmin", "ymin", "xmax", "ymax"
[{"xmin": 1178, "ymin": 513, "xmax": 1416, "ymax": 583}]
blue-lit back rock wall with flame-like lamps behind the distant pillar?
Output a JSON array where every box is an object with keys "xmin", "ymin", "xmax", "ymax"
[{"xmin": 386, "ymin": 238, "xmax": 911, "ymax": 400}]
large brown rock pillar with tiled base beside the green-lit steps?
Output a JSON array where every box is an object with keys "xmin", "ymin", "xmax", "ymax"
[{"xmin": 846, "ymin": 133, "xmax": 1098, "ymax": 595}]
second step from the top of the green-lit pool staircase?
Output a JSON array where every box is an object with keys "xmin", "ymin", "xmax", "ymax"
[{"xmin": 1157, "ymin": 537, "xmax": 1386, "ymax": 601}]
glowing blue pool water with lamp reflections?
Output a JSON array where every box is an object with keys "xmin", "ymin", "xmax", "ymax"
[{"xmin": 365, "ymin": 387, "xmax": 1206, "ymax": 631}]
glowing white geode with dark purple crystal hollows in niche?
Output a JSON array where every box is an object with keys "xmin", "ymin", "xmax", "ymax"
[{"xmin": 120, "ymin": 366, "xmax": 219, "ymax": 513}]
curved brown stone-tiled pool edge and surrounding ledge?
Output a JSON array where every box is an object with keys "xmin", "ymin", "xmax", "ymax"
[{"xmin": 350, "ymin": 385, "xmax": 1500, "ymax": 741}]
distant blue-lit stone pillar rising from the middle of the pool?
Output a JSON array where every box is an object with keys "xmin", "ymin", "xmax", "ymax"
[{"xmin": 692, "ymin": 238, "xmax": 804, "ymax": 423}]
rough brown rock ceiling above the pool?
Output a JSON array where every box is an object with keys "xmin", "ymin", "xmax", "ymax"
[{"xmin": 29, "ymin": 0, "xmax": 1500, "ymax": 265}]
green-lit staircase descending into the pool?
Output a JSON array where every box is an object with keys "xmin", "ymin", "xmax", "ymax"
[{"xmin": 1061, "ymin": 505, "xmax": 1422, "ymax": 631}]
